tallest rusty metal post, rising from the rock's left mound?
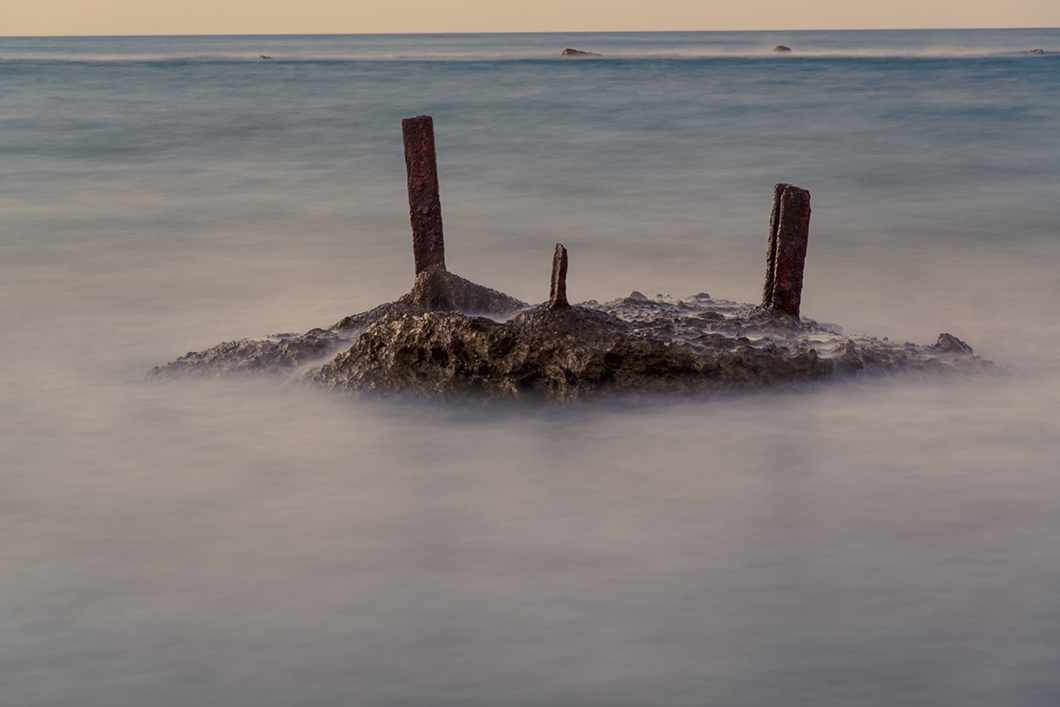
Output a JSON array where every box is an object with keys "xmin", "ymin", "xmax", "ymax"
[{"xmin": 401, "ymin": 116, "xmax": 445, "ymax": 275}]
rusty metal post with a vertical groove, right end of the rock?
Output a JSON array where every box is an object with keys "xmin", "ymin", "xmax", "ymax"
[{"xmin": 762, "ymin": 184, "xmax": 810, "ymax": 317}]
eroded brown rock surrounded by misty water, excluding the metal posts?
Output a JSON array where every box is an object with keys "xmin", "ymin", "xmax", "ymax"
[{"xmin": 149, "ymin": 288, "xmax": 997, "ymax": 400}]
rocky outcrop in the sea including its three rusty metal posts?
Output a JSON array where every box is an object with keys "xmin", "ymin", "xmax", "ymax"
[{"xmin": 147, "ymin": 116, "xmax": 997, "ymax": 401}]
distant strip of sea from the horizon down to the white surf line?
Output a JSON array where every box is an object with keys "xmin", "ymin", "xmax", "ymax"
[{"xmin": 0, "ymin": 30, "xmax": 1060, "ymax": 64}]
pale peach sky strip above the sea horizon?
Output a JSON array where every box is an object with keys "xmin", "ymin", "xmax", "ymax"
[{"xmin": 0, "ymin": 0, "xmax": 1060, "ymax": 36}]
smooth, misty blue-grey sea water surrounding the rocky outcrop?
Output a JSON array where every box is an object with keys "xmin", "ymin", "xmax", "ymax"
[{"xmin": 0, "ymin": 30, "xmax": 1060, "ymax": 707}]
